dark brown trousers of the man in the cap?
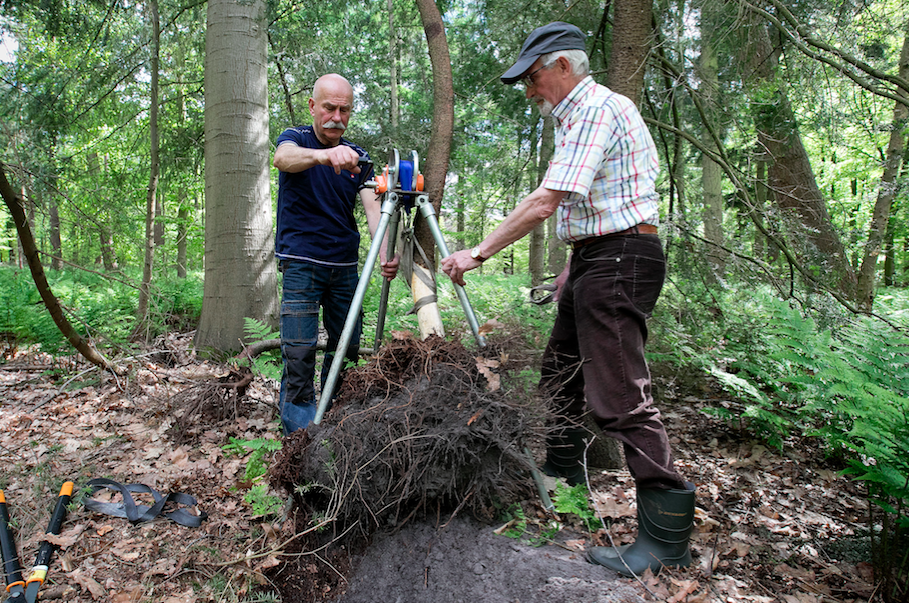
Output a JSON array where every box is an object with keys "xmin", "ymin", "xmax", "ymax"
[{"xmin": 540, "ymin": 234, "xmax": 685, "ymax": 489}]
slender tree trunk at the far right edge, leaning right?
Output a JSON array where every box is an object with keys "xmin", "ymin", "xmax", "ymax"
[{"xmin": 857, "ymin": 24, "xmax": 909, "ymax": 312}]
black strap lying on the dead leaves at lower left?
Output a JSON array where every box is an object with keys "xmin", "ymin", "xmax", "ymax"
[{"xmin": 84, "ymin": 477, "xmax": 208, "ymax": 528}]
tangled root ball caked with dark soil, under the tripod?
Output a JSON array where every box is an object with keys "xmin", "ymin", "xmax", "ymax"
[{"xmin": 271, "ymin": 337, "xmax": 542, "ymax": 534}]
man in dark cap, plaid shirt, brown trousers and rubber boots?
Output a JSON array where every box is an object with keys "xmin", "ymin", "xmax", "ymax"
[{"xmin": 442, "ymin": 22, "xmax": 694, "ymax": 576}]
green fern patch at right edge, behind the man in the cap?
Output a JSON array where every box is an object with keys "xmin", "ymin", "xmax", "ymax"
[{"xmin": 658, "ymin": 280, "xmax": 909, "ymax": 600}]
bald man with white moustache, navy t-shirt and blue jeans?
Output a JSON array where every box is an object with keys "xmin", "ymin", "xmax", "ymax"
[{"xmin": 274, "ymin": 74, "xmax": 398, "ymax": 435}]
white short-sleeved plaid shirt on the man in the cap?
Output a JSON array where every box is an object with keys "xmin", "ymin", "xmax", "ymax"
[{"xmin": 542, "ymin": 76, "xmax": 659, "ymax": 241}]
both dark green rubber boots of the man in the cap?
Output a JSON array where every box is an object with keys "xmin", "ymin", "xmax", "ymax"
[{"xmin": 543, "ymin": 428, "xmax": 694, "ymax": 577}]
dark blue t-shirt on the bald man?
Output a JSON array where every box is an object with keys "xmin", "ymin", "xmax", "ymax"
[{"xmin": 275, "ymin": 126, "xmax": 373, "ymax": 266}]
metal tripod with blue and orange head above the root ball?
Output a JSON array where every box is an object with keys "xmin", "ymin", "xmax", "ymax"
[{"xmin": 313, "ymin": 149, "xmax": 486, "ymax": 425}]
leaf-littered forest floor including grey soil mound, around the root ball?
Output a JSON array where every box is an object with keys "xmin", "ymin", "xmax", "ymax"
[{"xmin": 0, "ymin": 335, "xmax": 874, "ymax": 603}]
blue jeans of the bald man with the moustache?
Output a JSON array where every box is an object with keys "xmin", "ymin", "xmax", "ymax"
[{"xmin": 278, "ymin": 260, "xmax": 362, "ymax": 435}]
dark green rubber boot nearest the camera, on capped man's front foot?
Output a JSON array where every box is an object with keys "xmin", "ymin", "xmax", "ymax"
[{"xmin": 587, "ymin": 488, "xmax": 694, "ymax": 577}]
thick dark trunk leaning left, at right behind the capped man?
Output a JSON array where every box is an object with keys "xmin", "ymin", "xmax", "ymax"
[{"xmin": 744, "ymin": 8, "xmax": 856, "ymax": 300}]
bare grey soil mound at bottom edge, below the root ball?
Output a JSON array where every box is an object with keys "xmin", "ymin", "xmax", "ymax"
[{"xmin": 337, "ymin": 517, "xmax": 643, "ymax": 603}]
